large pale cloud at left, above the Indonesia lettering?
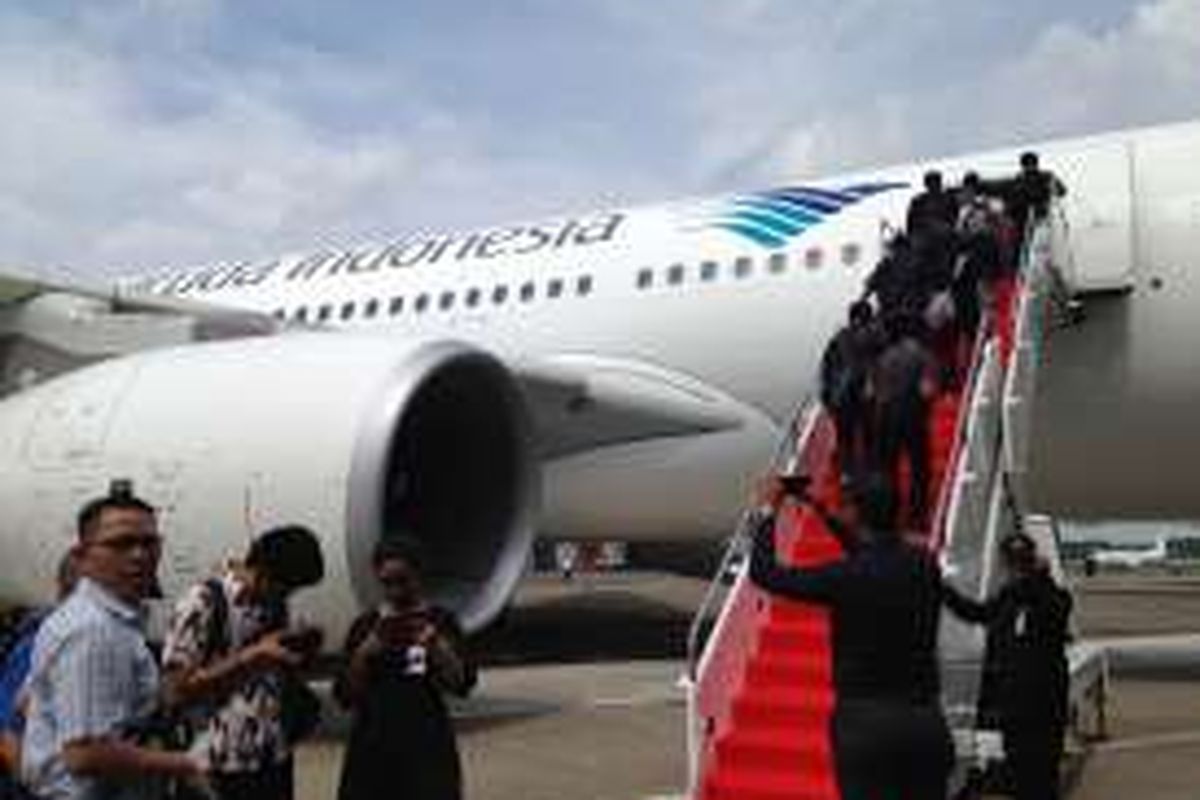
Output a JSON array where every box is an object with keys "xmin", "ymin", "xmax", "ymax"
[{"xmin": 0, "ymin": 6, "xmax": 633, "ymax": 273}]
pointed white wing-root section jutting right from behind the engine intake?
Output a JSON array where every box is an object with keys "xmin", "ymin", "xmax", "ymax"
[{"xmin": 511, "ymin": 355, "xmax": 761, "ymax": 458}]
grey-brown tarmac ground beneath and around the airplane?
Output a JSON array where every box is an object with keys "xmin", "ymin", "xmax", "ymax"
[{"xmin": 296, "ymin": 572, "xmax": 1200, "ymax": 800}]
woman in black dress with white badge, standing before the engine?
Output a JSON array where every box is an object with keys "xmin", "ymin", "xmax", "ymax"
[{"xmin": 335, "ymin": 539, "xmax": 475, "ymax": 800}]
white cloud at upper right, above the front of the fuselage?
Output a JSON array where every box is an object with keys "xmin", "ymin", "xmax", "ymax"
[{"xmin": 729, "ymin": 0, "xmax": 1200, "ymax": 181}]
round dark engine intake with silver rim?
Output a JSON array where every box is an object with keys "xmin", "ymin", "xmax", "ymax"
[{"xmin": 348, "ymin": 344, "xmax": 535, "ymax": 630}]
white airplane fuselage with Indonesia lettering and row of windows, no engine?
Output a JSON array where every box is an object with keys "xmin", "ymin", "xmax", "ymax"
[{"xmin": 121, "ymin": 117, "xmax": 1200, "ymax": 537}]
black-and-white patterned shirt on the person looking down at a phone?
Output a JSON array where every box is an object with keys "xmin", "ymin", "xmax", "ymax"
[{"xmin": 163, "ymin": 569, "xmax": 289, "ymax": 774}]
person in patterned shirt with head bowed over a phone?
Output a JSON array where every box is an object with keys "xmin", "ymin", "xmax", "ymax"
[{"xmin": 163, "ymin": 525, "xmax": 324, "ymax": 800}]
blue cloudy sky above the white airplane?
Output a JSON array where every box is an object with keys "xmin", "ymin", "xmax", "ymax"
[{"xmin": 0, "ymin": 0, "xmax": 1200, "ymax": 277}]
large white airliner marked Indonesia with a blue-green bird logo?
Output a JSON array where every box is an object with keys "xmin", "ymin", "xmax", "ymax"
[{"xmin": 0, "ymin": 122, "xmax": 1200, "ymax": 640}]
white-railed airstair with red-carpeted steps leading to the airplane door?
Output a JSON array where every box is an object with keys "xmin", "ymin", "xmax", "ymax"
[{"xmin": 684, "ymin": 211, "xmax": 1106, "ymax": 800}]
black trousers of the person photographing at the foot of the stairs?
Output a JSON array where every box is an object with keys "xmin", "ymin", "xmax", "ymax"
[{"xmin": 832, "ymin": 700, "xmax": 954, "ymax": 800}]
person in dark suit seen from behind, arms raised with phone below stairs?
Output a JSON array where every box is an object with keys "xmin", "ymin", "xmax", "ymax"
[{"xmin": 750, "ymin": 474, "xmax": 953, "ymax": 800}]
